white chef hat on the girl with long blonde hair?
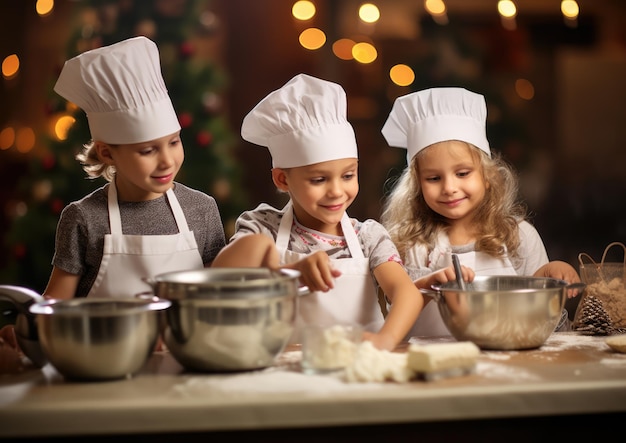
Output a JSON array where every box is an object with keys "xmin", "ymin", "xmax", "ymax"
[{"xmin": 382, "ymin": 88, "xmax": 491, "ymax": 163}]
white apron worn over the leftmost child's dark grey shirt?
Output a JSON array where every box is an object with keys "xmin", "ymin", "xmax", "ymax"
[{"xmin": 87, "ymin": 182, "xmax": 204, "ymax": 297}]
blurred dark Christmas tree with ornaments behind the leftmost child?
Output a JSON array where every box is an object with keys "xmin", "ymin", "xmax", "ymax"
[{"xmin": 0, "ymin": 0, "xmax": 247, "ymax": 292}]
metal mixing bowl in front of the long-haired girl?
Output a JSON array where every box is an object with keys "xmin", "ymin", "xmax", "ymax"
[{"xmin": 432, "ymin": 276, "xmax": 578, "ymax": 350}]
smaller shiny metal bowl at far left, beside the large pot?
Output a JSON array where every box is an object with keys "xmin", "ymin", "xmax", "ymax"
[{"xmin": 30, "ymin": 298, "xmax": 170, "ymax": 380}]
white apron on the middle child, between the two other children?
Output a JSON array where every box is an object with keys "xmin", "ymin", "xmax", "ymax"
[{"xmin": 276, "ymin": 201, "xmax": 384, "ymax": 343}]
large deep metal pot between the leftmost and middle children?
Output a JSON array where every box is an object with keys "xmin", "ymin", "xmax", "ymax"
[{"xmin": 147, "ymin": 268, "xmax": 306, "ymax": 372}]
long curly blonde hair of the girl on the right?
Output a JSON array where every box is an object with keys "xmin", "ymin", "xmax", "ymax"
[{"xmin": 381, "ymin": 142, "xmax": 527, "ymax": 259}]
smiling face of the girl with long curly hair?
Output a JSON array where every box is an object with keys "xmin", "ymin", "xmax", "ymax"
[{"xmin": 418, "ymin": 140, "xmax": 487, "ymax": 231}]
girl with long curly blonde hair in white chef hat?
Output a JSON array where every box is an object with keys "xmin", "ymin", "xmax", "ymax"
[{"xmin": 382, "ymin": 88, "xmax": 580, "ymax": 335}]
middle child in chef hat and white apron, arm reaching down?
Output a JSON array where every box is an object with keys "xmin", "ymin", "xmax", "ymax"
[{"xmin": 231, "ymin": 74, "xmax": 466, "ymax": 349}]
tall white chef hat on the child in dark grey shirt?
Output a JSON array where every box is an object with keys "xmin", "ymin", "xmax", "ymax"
[{"xmin": 54, "ymin": 37, "xmax": 180, "ymax": 144}]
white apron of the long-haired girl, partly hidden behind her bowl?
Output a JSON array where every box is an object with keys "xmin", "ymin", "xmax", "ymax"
[{"xmin": 409, "ymin": 246, "xmax": 517, "ymax": 336}]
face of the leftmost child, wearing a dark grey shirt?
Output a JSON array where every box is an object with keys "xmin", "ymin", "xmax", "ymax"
[{"xmin": 96, "ymin": 132, "xmax": 185, "ymax": 201}]
